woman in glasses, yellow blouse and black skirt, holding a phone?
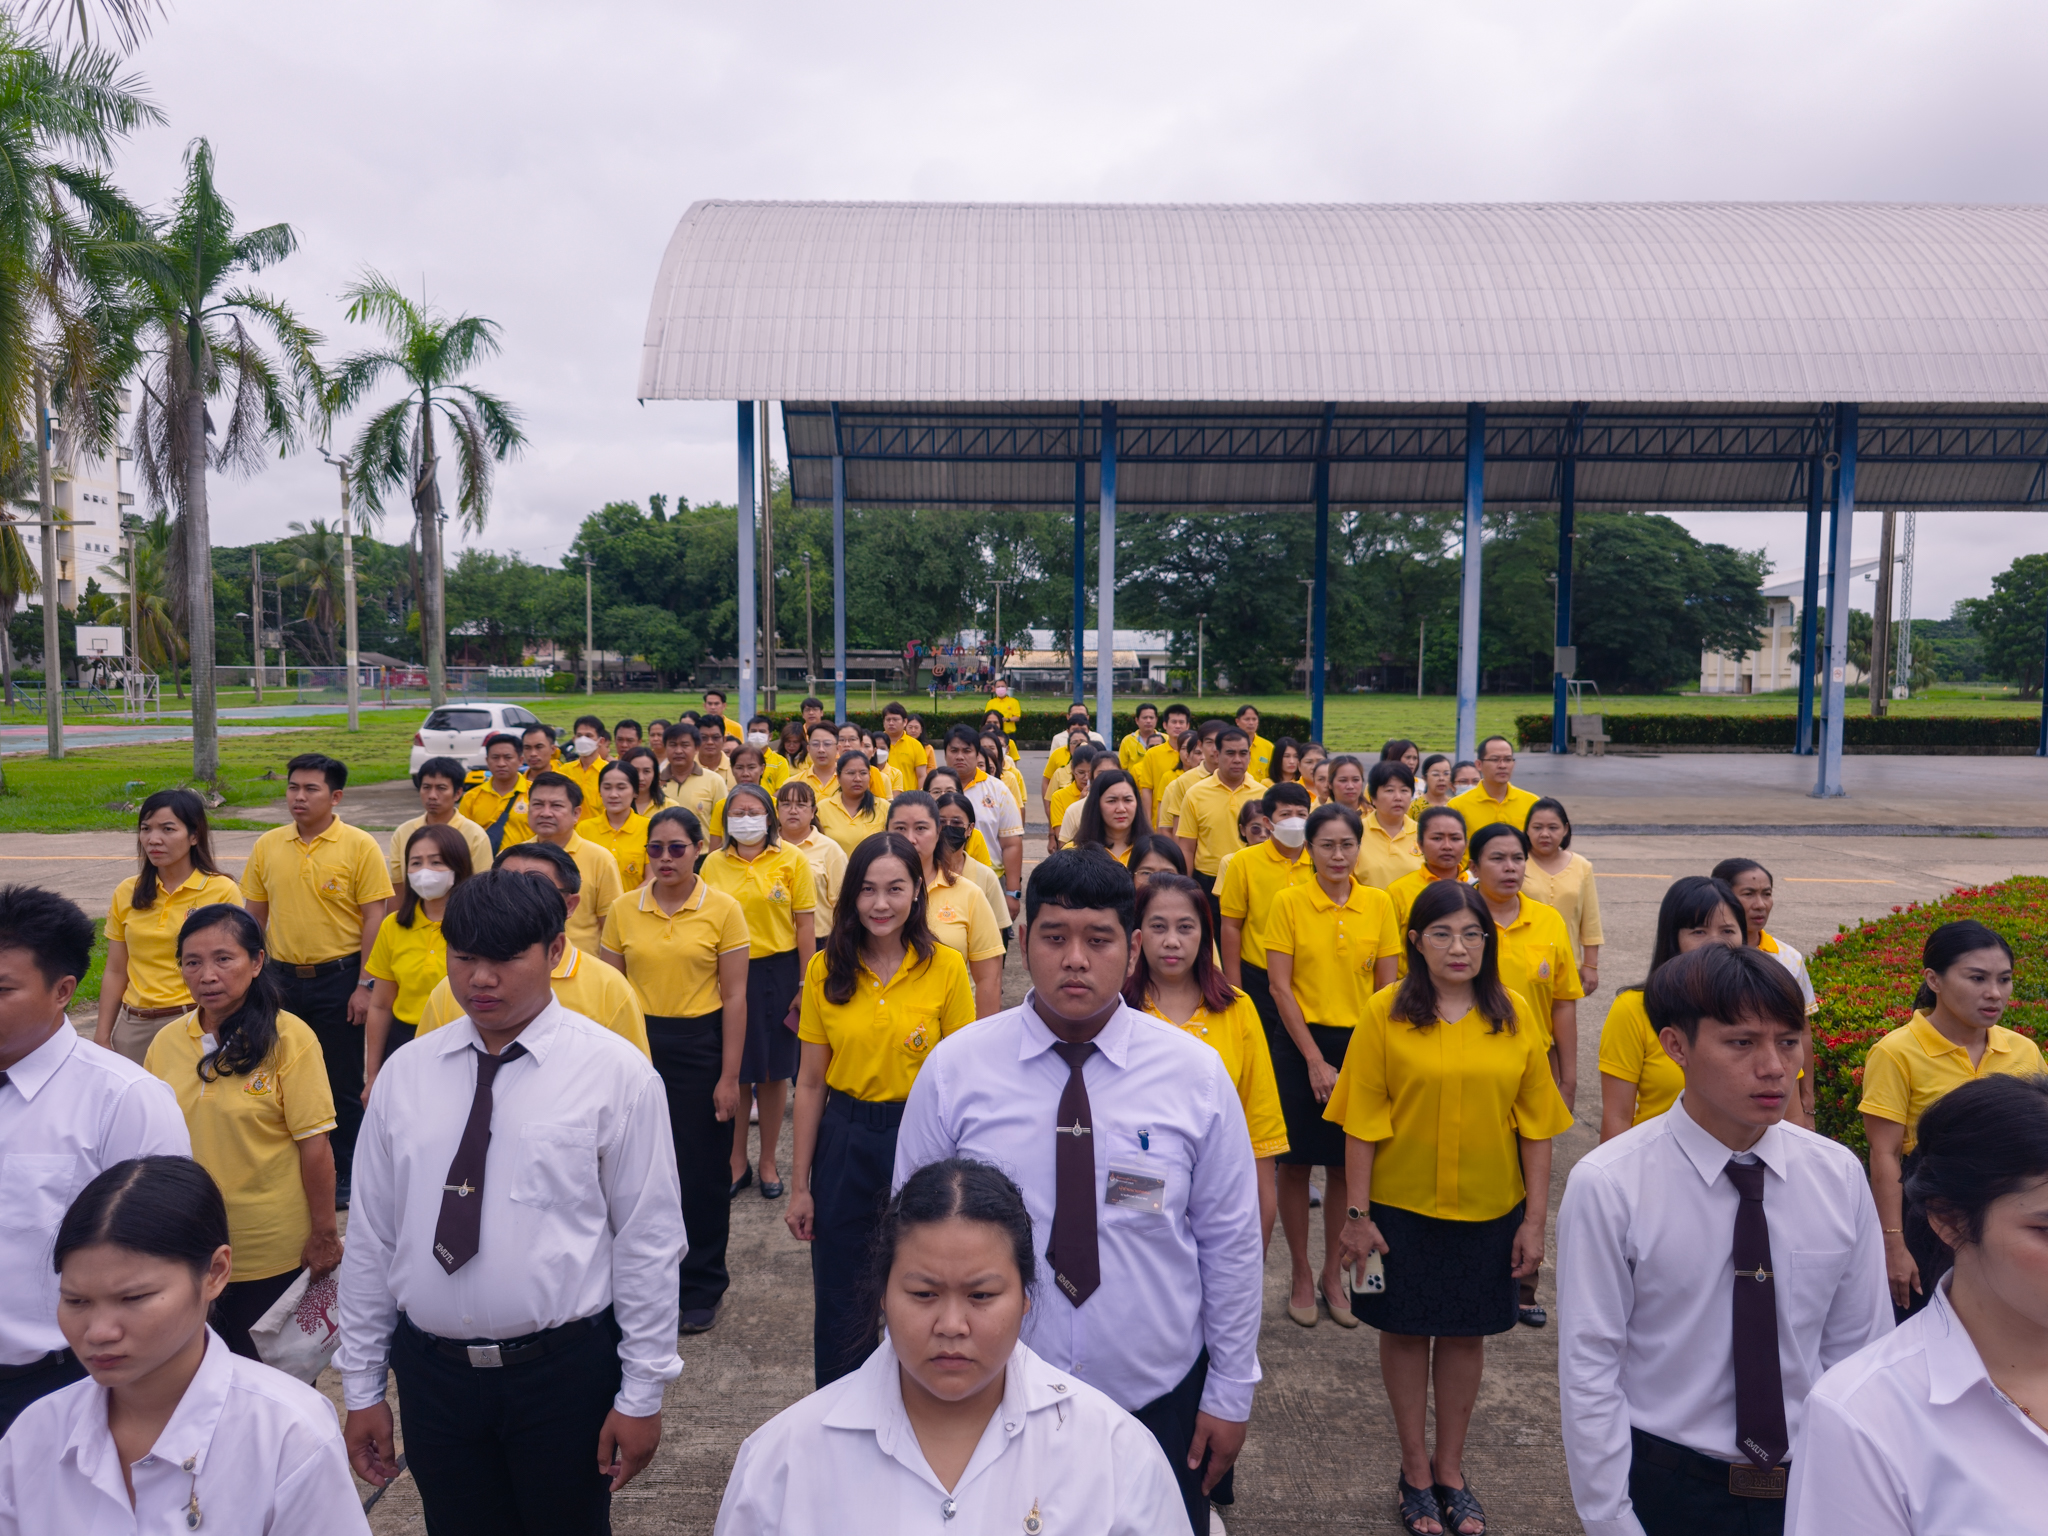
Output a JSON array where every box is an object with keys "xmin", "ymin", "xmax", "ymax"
[{"xmin": 1325, "ymin": 881, "xmax": 1571, "ymax": 1536}]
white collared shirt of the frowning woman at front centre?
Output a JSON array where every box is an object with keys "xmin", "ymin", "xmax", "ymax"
[{"xmin": 713, "ymin": 1341, "xmax": 1188, "ymax": 1536}]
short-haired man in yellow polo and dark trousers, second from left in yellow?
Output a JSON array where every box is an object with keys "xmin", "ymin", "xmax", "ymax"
[{"xmin": 242, "ymin": 752, "xmax": 391, "ymax": 1208}]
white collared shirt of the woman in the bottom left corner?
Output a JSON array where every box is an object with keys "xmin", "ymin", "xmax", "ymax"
[{"xmin": 0, "ymin": 1327, "xmax": 371, "ymax": 1536}]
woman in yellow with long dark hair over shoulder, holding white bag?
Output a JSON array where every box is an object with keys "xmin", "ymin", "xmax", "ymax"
[{"xmin": 143, "ymin": 901, "xmax": 337, "ymax": 1360}]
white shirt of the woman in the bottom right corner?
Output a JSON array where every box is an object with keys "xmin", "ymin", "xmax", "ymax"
[{"xmin": 1786, "ymin": 1276, "xmax": 2048, "ymax": 1536}]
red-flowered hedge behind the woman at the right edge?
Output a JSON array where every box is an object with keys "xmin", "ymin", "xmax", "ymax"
[{"xmin": 1806, "ymin": 874, "xmax": 2048, "ymax": 1157}]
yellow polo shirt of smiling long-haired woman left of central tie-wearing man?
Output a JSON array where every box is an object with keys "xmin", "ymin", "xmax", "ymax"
[{"xmin": 797, "ymin": 944, "xmax": 975, "ymax": 1104}]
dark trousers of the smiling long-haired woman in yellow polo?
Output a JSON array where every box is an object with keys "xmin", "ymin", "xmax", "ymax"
[{"xmin": 811, "ymin": 1094, "xmax": 903, "ymax": 1386}]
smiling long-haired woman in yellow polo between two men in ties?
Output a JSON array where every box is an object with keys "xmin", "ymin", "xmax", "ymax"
[{"xmin": 782, "ymin": 831, "xmax": 975, "ymax": 1386}]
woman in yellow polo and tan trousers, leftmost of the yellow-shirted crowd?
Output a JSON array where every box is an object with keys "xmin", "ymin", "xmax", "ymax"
[{"xmin": 92, "ymin": 788, "xmax": 242, "ymax": 1067}]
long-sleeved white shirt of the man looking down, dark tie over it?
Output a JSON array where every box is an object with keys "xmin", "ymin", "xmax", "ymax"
[{"xmin": 334, "ymin": 1001, "xmax": 684, "ymax": 1417}]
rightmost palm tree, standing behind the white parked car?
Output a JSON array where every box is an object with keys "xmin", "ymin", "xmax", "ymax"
[{"xmin": 326, "ymin": 272, "xmax": 526, "ymax": 705}]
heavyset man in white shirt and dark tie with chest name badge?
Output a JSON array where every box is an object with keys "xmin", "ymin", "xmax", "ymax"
[{"xmin": 895, "ymin": 848, "xmax": 1264, "ymax": 1536}]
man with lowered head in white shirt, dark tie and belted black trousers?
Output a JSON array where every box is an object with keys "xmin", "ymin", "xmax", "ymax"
[{"xmin": 334, "ymin": 870, "xmax": 684, "ymax": 1536}]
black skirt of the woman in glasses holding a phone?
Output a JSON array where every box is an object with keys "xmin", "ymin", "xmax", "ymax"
[{"xmin": 1346, "ymin": 1200, "xmax": 1524, "ymax": 1339}]
